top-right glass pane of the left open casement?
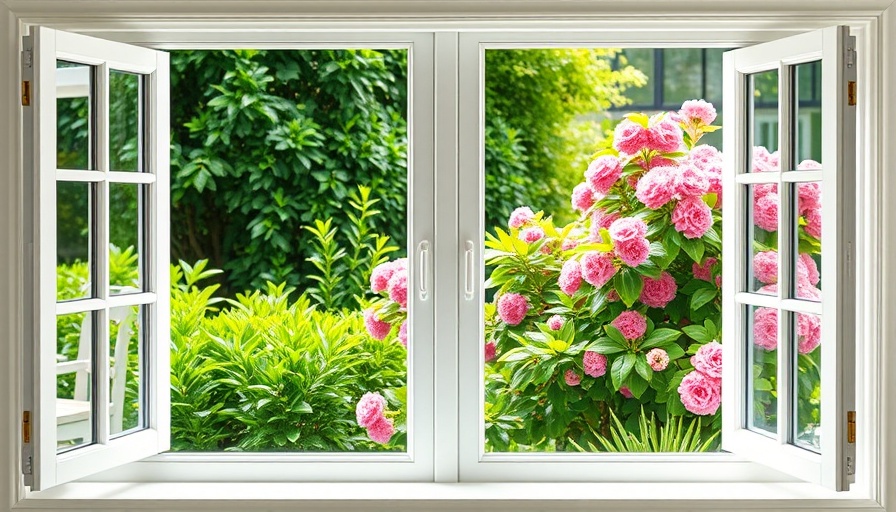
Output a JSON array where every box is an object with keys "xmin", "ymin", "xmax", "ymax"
[{"xmin": 109, "ymin": 69, "xmax": 143, "ymax": 171}]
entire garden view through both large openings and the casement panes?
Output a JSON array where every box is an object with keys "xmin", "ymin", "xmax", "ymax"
[{"xmin": 57, "ymin": 49, "xmax": 821, "ymax": 452}]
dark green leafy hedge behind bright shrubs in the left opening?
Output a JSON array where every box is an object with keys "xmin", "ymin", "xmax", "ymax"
[{"xmin": 171, "ymin": 50, "xmax": 407, "ymax": 296}]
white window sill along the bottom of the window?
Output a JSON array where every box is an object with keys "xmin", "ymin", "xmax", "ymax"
[{"xmin": 14, "ymin": 482, "xmax": 884, "ymax": 512}]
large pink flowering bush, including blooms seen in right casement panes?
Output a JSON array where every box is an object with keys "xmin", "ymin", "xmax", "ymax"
[{"xmin": 485, "ymin": 100, "xmax": 820, "ymax": 451}]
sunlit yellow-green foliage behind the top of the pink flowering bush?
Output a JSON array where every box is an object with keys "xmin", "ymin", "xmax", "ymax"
[{"xmin": 485, "ymin": 48, "xmax": 647, "ymax": 226}]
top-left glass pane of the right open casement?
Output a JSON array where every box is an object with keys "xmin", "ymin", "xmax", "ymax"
[{"xmin": 749, "ymin": 69, "xmax": 780, "ymax": 172}]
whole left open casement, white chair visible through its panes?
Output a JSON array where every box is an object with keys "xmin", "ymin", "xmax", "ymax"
[{"xmin": 23, "ymin": 27, "xmax": 169, "ymax": 490}]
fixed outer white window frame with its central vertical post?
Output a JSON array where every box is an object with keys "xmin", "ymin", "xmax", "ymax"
[{"xmin": 0, "ymin": 0, "xmax": 896, "ymax": 510}]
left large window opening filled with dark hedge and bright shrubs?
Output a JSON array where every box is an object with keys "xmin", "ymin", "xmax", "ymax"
[{"xmin": 166, "ymin": 49, "xmax": 408, "ymax": 453}]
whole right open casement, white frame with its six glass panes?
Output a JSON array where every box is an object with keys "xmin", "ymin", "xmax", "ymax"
[{"xmin": 722, "ymin": 27, "xmax": 856, "ymax": 490}]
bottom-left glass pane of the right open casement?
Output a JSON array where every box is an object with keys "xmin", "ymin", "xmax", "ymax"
[{"xmin": 746, "ymin": 306, "xmax": 779, "ymax": 434}]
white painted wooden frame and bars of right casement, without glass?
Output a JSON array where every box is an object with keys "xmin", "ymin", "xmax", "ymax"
[{"xmin": 722, "ymin": 27, "xmax": 855, "ymax": 490}]
